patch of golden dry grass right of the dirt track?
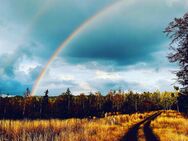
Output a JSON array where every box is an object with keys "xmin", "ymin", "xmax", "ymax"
[{"xmin": 151, "ymin": 110, "xmax": 188, "ymax": 141}]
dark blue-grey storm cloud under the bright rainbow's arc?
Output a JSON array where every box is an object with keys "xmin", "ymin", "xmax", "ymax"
[{"xmin": 62, "ymin": 0, "xmax": 185, "ymax": 65}]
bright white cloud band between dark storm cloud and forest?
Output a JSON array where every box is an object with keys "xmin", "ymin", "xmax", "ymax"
[{"xmin": 34, "ymin": 53, "xmax": 175, "ymax": 95}]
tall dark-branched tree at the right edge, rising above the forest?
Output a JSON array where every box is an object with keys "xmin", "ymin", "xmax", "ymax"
[{"xmin": 164, "ymin": 13, "xmax": 188, "ymax": 95}]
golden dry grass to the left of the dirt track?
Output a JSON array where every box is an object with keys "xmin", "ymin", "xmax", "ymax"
[{"xmin": 0, "ymin": 112, "xmax": 153, "ymax": 141}]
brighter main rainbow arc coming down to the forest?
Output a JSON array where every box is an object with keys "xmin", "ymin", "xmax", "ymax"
[{"xmin": 31, "ymin": 0, "xmax": 128, "ymax": 96}]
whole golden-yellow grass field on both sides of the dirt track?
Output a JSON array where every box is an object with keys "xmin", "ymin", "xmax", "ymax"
[{"xmin": 0, "ymin": 111, "xmax": 188, "ymax": 141}]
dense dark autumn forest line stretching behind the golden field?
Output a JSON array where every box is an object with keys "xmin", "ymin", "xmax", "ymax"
[{"xmin": 0, "ymin": 89, "xmax": 181, "ymax": 119}]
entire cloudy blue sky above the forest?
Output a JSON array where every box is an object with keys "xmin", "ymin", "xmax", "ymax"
[{"xmin": 0, "ymin": 0, "xmax": 188, "ymax": 95}]
